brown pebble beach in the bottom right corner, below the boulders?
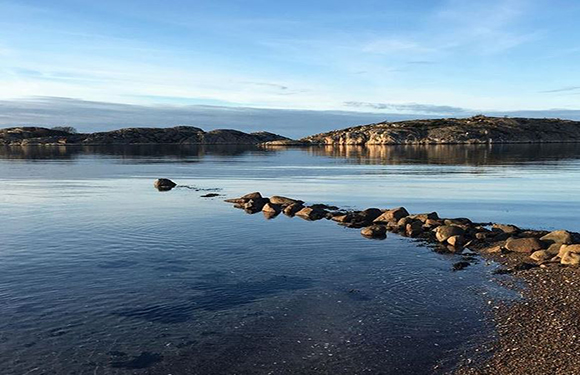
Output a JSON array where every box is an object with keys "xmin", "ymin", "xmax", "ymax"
[{"xmin": 455, "ymin": 265, "xmax": 580, "ymax": 375}]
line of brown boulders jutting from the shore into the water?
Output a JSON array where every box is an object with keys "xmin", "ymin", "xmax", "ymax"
[{"xmin": 225, "ymin": 192, "xmax": 580, "ymax": 266}]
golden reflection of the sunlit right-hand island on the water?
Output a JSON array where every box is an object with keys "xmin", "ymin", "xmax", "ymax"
[{"xmin": 271, "ymin": 143, "xmax": 580, "ymax": 165}]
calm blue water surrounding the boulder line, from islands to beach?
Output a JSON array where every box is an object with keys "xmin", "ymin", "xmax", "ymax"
[{"xmin": 0, "ymin": 144, "xmax": 580, "ymax": 374}]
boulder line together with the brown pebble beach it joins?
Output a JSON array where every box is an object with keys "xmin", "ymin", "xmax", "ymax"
[{"xmin": 220, "ymin": 192, "xmax": 580, "ymax": 375}]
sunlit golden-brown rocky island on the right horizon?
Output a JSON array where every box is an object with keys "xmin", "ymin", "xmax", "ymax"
[{"xmin": 290, "ymin": 115, "xmax": 580, "ymax": 145}]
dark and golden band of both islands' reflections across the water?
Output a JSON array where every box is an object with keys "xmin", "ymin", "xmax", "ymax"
[{"xmin": 0, "ymin": 143, "xmax": 580, "ymax": 166}]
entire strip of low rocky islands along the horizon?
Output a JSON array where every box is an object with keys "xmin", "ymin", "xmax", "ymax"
[{"xmin": 0, "ymin": 115, "xmax": 580, "ymax": 147}]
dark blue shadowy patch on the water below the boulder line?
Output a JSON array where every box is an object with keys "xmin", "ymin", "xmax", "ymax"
[{"xmin": 115, "ymin": 276, "xmax": 312, "ymax": 323}]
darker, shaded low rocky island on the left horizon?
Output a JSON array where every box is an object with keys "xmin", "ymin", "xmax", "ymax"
[{"xmin": 0, "ymin": 126, "xmax": 288, "ymax": 145}]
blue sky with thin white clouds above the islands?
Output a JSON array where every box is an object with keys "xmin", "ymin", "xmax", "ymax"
[{"xmin": 0, "ymin": 0, "xmax": 580, "ymax": 136}]
